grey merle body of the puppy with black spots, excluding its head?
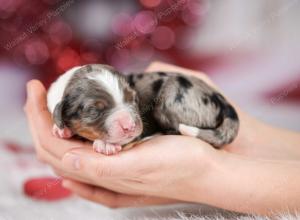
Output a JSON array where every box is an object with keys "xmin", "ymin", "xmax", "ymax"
[{"xmin": 127, "ymin": 72, "xmax": 239, "ymax": 148}]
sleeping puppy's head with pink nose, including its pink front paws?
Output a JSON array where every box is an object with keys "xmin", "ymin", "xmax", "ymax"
[{"xmin": 47, "ymin": 64, "xmax": 143, "ymax": 155}]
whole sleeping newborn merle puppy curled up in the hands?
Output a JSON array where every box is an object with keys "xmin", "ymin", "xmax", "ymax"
[{"xmin": 47, "ymin": 64, "xmax": 239, "ymax": 155}]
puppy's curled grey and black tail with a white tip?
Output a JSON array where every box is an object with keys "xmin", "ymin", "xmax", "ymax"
[{"xmin": 178, "ymin": 105, "xmax": 239, "ymax": 148}]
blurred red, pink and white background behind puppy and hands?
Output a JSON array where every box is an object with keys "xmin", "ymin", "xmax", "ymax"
[{"xmin": 0, "ymin": 0, "xmax": 300, "ymax": 219}]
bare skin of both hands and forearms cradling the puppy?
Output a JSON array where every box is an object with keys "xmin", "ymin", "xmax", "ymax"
[{"xmin": 25, "ymin": 62, "xmax": 300, "ymax": 215}]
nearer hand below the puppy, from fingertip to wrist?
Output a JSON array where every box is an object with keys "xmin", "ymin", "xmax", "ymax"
[{"xmin": 62, "ymin": 135, "xmax": 216, "ymax": 201}]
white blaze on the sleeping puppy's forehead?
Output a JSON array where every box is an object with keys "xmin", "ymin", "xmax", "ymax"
[{"xmin": 88, "ymin": 69, "xmax": 124, "ymax": 104}]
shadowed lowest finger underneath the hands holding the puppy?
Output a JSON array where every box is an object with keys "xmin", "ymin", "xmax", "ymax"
[{"xmin": 62, "ymin": 180, "xmax": 177, "ymax": 208}]
